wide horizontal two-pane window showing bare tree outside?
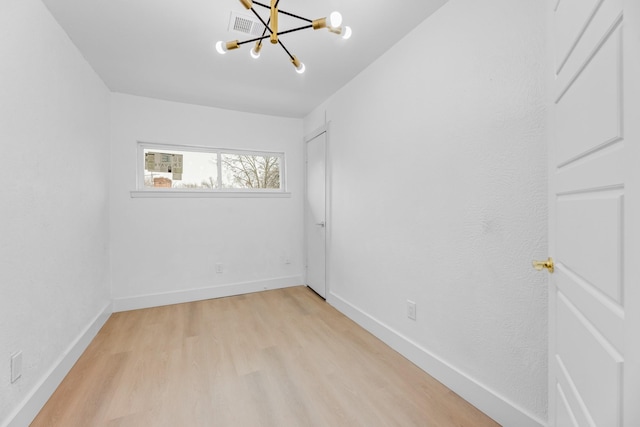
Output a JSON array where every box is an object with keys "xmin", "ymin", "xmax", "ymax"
[{"xmin": 132, "ymin": 143, "xmax": 285, "ymax": 195}]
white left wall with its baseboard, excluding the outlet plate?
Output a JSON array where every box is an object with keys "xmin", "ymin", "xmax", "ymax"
[{"xmin": 0, "ymin": 0, "xmax": 110, "ymax": 425}]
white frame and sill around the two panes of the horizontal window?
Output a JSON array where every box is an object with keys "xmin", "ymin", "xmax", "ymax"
[{"xmin": 130, "ymin": 141, "xmax": 291, "ymax": 198}]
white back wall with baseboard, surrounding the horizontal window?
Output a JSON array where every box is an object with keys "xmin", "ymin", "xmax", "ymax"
[{"xmin": 111, "ymin": 94, "xmax": 304, "ymax": 310}]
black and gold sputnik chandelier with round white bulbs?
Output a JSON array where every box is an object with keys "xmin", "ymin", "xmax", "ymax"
[{"xmin": 216, "ymin": 0, "xmax": 351, "ymax": 74}]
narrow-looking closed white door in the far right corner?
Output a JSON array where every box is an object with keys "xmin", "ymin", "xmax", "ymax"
[{"xmin": 305, "ymin": 132, "xmax": 327, "ymax": 298}]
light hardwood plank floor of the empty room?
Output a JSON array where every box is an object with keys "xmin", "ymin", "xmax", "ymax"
[{"xmin": 32, "ymin": 287, "xmax": 498, "ymax": 427}]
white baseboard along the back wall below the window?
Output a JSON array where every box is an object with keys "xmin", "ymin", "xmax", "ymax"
[{"xmin": 113, "ymin": 276, "xmax": 304, "ymax": 312}]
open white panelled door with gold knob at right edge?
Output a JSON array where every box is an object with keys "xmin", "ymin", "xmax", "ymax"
[{"xmin": 549, "ymin": 0, "xmax": 640, "ymax": 427}]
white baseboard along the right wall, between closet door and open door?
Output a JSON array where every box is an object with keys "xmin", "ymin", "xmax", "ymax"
[{"xmin": 327, "ymin": 292, "xmax": 547, "ymax": 427}]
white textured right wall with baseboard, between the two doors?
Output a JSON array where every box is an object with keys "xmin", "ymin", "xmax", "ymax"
[{"xmin": 304, "ymin": 0, "xmax": 547, "ymax": 426}]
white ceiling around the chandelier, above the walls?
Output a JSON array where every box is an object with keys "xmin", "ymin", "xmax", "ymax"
[{"xmin": 43, "ymin": 0, "xmax": 447, "ymax": 117}]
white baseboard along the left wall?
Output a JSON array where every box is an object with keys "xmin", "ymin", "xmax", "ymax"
[{"xmin": 2, "ymin": 303, "xmax": 111, "ymax": 427}]
